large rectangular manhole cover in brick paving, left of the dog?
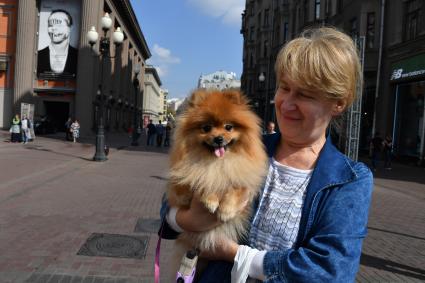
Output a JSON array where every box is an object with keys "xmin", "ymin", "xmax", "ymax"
[{"xmin": 77, "ymin": 233, "xmax": 149, "ymax": 259}]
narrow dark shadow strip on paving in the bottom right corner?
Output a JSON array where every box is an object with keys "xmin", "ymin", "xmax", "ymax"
[{"xmin": 360, "ymin": 253, "xmax": 425, "ymax": 280}]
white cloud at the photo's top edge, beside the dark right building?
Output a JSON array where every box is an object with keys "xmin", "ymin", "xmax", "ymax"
[{"xmin": 186, "ymin": 0, "xmax": 245, "ymax": 26}]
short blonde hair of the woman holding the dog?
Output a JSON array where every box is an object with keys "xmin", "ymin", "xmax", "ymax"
[{"xmin": 275, "ymin": 27, "xmax": 362, "ymax": 107}]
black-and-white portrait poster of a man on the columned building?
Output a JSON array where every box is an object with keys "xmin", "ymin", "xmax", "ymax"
[{"xmin": 37, "ymin": 0, "xmax": 81, "ymax": 79}]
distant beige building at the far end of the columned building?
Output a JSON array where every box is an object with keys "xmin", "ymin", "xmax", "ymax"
[{"xmin": 142, "ymin": 65, "xmax": 164, "ymax": 126}]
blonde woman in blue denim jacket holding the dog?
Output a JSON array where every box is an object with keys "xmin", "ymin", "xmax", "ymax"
[{"xmin": 159, "ymin": 28, "xmax": 373, "ymax": 282}]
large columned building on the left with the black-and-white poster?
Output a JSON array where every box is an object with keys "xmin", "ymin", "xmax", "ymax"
[{"xmin": 3, "ymin": 0, "xmax": 151, "ymax": 135}]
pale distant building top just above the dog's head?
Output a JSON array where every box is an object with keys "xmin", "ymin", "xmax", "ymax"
[{"xmin": 198, "ymin": 71, "xmax": 241, "ymax": 90}]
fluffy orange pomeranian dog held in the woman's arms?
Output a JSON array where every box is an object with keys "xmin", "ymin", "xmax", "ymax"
[{"xmin": 167, "ymin": 90, "xmax": 267, "ymax": 276}]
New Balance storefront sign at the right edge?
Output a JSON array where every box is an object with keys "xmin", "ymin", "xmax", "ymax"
[{"xmin": 390, "ymin": 54, "xmax": 425, "ymax": 81}]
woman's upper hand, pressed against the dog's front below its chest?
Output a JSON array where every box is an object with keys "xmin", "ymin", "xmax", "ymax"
[{"xmin": 176, "ymin": 195, "xmax": 221, "ymax": 232}]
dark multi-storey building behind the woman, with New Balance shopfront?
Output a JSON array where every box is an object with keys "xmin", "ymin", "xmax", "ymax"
[{"xmin": 241, "ymin": 0, "xmax": 425, "ymax": 160}]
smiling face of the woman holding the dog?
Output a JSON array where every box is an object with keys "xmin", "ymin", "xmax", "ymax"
[{"xmin": 274, "ymin": 76, "xmax": 344, "ymax": 145}]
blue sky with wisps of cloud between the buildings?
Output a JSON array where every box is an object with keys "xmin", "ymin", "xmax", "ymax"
[{"xmin": 131, "ymin": 0, "xmax": 245, "ymax": 98}]
